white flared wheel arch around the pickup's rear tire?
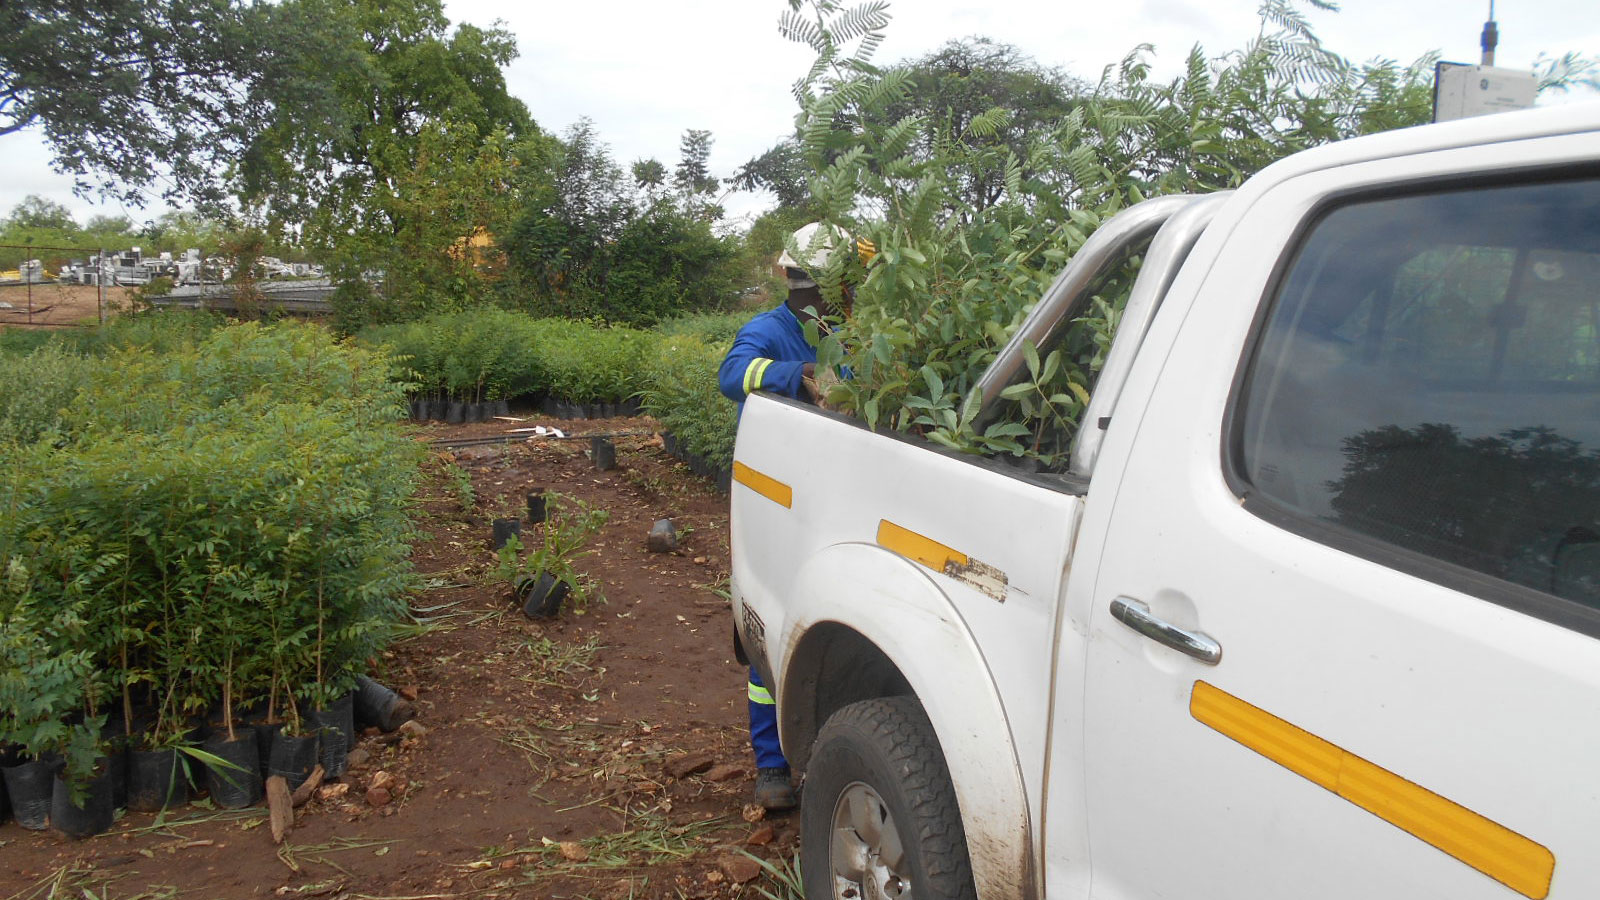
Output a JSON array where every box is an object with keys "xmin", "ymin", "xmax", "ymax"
[{"xmin": 778, "ymin": 544, "xmax": 1037, "ymax": 900}]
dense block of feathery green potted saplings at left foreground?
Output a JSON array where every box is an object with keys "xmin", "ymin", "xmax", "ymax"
[{"xmin": 0, "ymin": 320, "xmax": 422, "ymax": 753}]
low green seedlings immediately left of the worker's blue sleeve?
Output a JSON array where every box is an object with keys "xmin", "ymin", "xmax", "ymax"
[{"xmin": 642, "ymin": 335, "xmax": 739, "ymax": 469}]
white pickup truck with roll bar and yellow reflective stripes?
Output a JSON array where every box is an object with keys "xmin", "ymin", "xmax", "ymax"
[{"xmin": 731, "ymin": 99, "xmax": 1600, "ymax": 900}]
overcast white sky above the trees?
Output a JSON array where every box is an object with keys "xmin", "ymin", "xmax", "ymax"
[{"xmin": 0, "ymin": 0, "xmax": 1600, "ymax": 221}]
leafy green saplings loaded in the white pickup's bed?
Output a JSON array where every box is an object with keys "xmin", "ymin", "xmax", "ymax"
[{"xmin": 781, "ymin": 0, "xmax": 1430, "ymax": 464}]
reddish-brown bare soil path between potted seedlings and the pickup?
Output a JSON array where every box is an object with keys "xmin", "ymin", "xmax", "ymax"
[{"xmin": 0, "ymin": 420, "xmax": 797, "ymax": 900}]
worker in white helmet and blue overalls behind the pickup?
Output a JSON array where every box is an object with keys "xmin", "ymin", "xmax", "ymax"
[{"xmin": 717, "ymin": 223, "xmax": 875, "ymax": 810}]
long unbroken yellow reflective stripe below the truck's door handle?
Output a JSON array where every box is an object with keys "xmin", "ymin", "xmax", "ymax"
[{"xmin": 1189, "ymin": 681, "xmax": 1555, "ymax": 900}]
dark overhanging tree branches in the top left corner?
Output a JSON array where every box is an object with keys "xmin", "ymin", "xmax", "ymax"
[{"xmin": 0, "ymin": 0, "xmax": 276, "ymax": 205}]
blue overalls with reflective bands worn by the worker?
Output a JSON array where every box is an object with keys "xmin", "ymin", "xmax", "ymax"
[{"xmin": 717, "ymin": 304, "xmax": 816, "ymax": 769}]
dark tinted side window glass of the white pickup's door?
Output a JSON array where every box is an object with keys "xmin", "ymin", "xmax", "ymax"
[{"xmin": 1234, "ymin": 179, "xmax": 1600, "ymax": 610}]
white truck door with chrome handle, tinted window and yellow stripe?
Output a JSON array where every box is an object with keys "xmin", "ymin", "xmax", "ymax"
[{"xmin": 1058, "ymin": 136, "xmax": 1600, "ymax": 900}]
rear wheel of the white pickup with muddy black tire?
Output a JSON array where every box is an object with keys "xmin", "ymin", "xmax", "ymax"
[{"xmin": 800, "ymin": 697, "xmax": 978, "ymax": 900}]
